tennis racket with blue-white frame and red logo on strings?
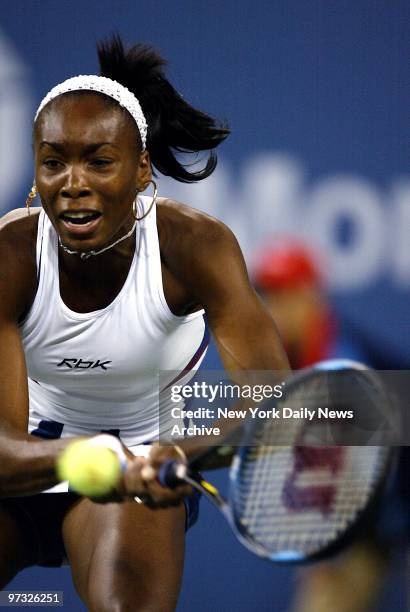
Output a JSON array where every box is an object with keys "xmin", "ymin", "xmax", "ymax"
[{"xmin": 159, "ymin": 360, "xmax": 394, "ymax": 563}]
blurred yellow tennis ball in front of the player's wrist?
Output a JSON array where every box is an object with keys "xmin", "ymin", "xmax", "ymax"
[{"xmin": 57, "ymin": 440, "xmax": 121, "ymax": 497}]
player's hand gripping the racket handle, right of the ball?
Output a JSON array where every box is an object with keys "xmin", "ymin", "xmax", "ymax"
[{"xmin": 123, "ymin": 444, "xmax": 192, "ymax": 508}]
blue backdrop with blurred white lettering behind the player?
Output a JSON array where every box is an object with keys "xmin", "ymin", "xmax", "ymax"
[{"xmin": 0, "ymin": 0, "xmax": 410, "ymax": 612}]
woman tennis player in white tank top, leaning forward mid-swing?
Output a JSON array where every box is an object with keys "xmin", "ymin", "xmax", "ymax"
[{"xmin": 0, "ymin": 38, "xmax": 287, "ymax": 612}]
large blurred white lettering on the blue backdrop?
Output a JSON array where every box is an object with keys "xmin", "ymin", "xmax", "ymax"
[{"xmin": 160, "ymin": 153, "xmax": 410, "ymax": 291}]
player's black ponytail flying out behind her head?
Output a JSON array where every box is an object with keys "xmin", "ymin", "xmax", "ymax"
[{"xmin": 97, "ymin": 35, "xmax": 230, "ymax": 183}]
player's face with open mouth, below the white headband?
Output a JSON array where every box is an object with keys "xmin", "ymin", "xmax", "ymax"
[{"xmin": 34, "ymin": 94, "xmax": 151, "ymax": 251}]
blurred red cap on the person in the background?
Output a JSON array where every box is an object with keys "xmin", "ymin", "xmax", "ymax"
[{"xmin": 253, "ymin": 240, "xmax": 321, "ymax": 289}]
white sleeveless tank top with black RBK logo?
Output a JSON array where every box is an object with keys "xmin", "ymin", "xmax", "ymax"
[{"xmin": 20, "ymin": 197, "xmax": 209, "ymax": 446}]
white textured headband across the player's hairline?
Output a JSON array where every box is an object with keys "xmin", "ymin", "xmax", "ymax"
[{"xmin": 34, "ymin": 74, "xmax": 147, "ymax": 151}]
